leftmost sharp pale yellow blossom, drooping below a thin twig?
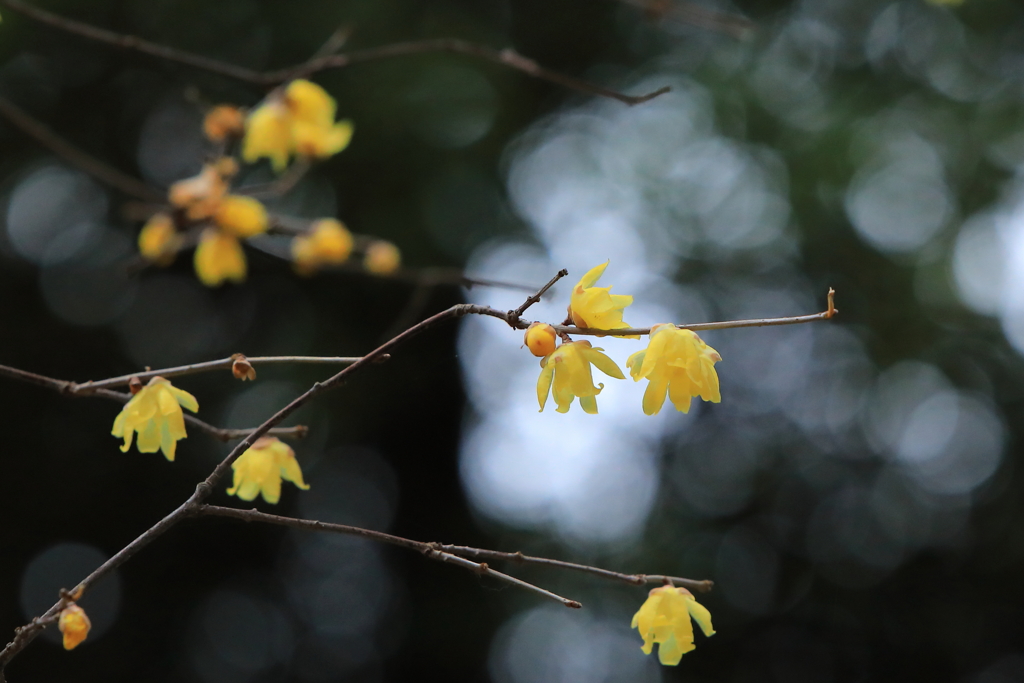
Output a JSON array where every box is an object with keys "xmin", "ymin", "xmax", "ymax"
[{"xmin": 111, "ymin": 377, "xmax": 199, "ymax": 461}]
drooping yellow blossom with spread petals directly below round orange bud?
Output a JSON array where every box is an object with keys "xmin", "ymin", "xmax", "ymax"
[{"xmin": 537, "ymin": 341, "xmax": 626, "ymax": 415}]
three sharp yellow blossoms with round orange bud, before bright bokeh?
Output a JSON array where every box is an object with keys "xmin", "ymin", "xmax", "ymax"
[{"xmin": 524, "ymin": 262, "xmax": 722, "ymax": 415}]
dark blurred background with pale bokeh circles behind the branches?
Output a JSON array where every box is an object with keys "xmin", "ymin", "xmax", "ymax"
[{"xmin": 0, "ymin": 0, "xmax": 1024, "ymax": 683}]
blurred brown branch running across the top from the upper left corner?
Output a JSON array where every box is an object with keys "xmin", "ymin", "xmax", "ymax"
[{"xmin": 0, "ymin": 0, "xmax": 671, "ymax": 105}]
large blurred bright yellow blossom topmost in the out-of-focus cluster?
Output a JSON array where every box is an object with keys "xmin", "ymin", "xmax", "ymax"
[{"xmin": 242, "ymin": 79, "xmax": 352, "ymax": 172}]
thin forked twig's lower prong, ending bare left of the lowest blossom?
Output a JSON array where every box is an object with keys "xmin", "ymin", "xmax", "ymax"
[{"xmin": 191, "ymin": 505, "xmax": 583, "ymax": 609}]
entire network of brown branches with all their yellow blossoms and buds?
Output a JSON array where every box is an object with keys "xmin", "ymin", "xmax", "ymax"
[{"xmin": 0, "ymin": 0, "xmax": 856, "ymax": 681}]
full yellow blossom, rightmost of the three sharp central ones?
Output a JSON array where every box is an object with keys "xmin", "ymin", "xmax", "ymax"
[{"xmin": 626, "ymin": 324, "xmax": 722, "ymax": 415}]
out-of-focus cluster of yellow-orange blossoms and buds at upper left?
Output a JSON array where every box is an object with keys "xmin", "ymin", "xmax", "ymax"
[{"xmin": 138, "ymin": 79, "xmax": 401, "ymax": 287}]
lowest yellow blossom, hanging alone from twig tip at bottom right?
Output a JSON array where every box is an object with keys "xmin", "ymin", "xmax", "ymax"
[{"xmin": 632, "ymin": 586, "xmax": 715, "ymax": 667}]
